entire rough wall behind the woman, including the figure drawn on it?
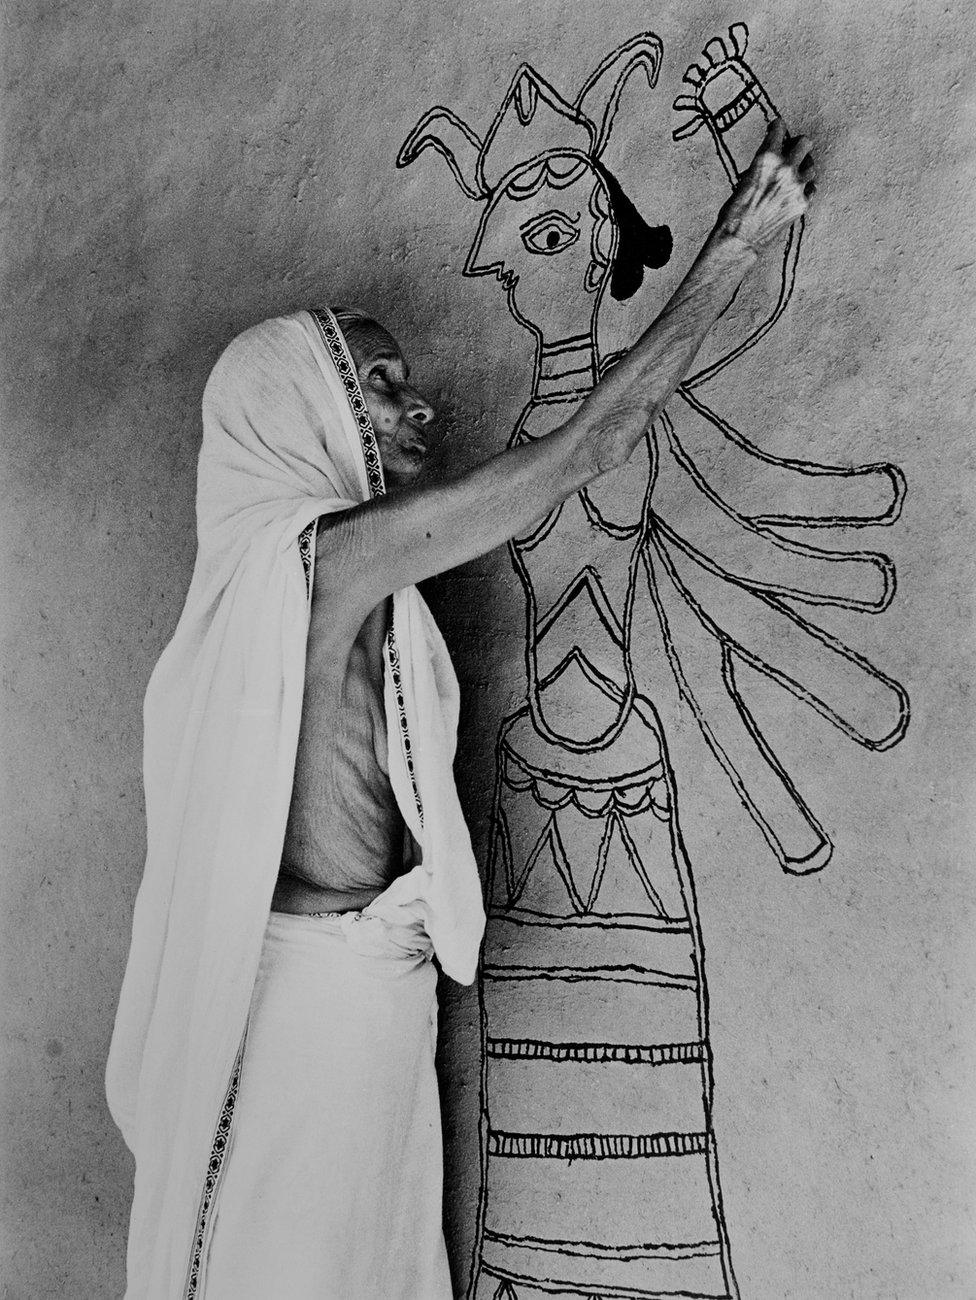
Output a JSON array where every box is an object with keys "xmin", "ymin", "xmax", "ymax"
[{"xmin": 0, "ymin": 0, "xmax": 976, "ymax": 1300}]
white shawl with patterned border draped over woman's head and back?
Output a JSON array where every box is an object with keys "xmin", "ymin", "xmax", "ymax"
[{"xmin": 107, "ymin": 312, "xmax": 483, "ymax": 1300}]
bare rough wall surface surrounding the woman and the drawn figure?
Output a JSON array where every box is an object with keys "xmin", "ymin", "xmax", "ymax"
[{"xmin": 0, "ymin": 0, "xmax": 976, "ymax": 1300}]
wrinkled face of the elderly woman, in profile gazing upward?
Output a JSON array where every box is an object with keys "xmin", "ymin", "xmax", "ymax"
[{"xmin": 343, "ymin": 320, "xmax": 434, "ymax": 491}]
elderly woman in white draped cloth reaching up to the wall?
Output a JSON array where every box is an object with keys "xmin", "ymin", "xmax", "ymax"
[{"xmin": 108, "ymin": 124, "xmax": 814, "ymax": 1300}]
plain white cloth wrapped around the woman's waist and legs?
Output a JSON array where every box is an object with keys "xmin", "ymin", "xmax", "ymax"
[{"xmin": 200, "ymin": 911, "xmax": 454, "ymax": 1300}]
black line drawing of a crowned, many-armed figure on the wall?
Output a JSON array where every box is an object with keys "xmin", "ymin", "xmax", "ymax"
[{"xmin": 398, "ymin": 23, "xmax": 908, "ymax": 1300}]
